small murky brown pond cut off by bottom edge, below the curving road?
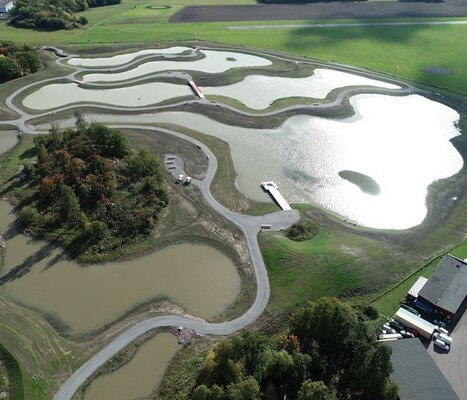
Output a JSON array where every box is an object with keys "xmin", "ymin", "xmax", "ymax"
[{"xmin": 84, "ymin": 333, "xmax": 180, "ymax": 400}]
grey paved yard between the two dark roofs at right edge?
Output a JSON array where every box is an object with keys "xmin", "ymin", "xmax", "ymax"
[{"xmin": 427, "ymin": 312, "xmax": 467, "ymax": 399}]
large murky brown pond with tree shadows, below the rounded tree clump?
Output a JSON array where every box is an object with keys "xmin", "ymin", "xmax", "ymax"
[{"xmin": 0, "ymin": 202, "xmax": 240, "ymax": 332}]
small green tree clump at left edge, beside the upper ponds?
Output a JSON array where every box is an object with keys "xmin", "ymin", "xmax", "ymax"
[{"xmin": 0, "ymin": 41, "xmax": 42, "ymax": 83}]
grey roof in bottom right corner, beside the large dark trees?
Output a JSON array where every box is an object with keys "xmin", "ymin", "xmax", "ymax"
[{"xmin": 384, "ymin": 338, "xmax": 459, "ymax": 400}]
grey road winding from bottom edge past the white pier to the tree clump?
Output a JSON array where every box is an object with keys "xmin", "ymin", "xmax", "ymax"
[{"xmin": 54, "ymin": 125, "xmax": 299, "ymax": 400}]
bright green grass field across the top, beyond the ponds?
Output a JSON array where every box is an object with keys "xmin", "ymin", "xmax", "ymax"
[{"xmin": 0, "ymin": 0, "xmax": 467, "ymax": 95}]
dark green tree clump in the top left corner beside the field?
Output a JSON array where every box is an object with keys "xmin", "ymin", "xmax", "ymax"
[{"xmin": 10, "ymin": 0, "xmax": 121, "ymax": 30}]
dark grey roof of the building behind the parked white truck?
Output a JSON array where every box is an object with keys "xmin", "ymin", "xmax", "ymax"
[{"xmin": 418, "ymin": 255, "xmax": 467, "ymax": 317}]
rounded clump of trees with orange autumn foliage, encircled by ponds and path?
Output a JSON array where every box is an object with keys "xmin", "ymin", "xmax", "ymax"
[{"xmin": 17, "ymin": 114, "xmax": 169, "ymax": 257}]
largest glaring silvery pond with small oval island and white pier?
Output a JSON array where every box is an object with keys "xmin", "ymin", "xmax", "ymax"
[{"xmin": 44, "ymin": 95, "xmax": 463, "ymax": 229}]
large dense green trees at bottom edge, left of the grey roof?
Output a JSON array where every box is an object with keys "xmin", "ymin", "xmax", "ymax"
[{"xmin": 190, "ymin": 298, "xmax": 397, "ymax": 400}]
